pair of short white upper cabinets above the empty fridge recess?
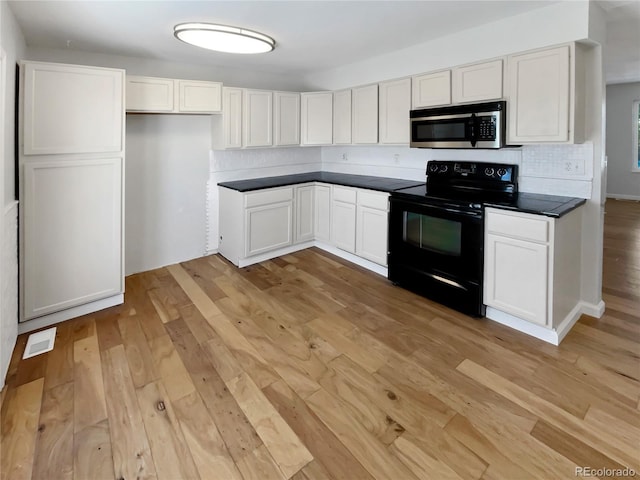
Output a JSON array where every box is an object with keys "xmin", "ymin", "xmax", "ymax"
[{"xmin": 126, "ymin": 75, "xmax": 222, "ymax": 114}]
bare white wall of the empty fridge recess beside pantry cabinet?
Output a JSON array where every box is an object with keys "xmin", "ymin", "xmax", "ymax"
[{"xmin": 125, "ymin": 114, "xmax": 211, "ymax": 275}]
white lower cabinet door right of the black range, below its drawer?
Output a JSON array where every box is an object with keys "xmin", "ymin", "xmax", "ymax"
[{"xmin": 484, "ymin": 233, "xmax": 549, "ymax": 326}]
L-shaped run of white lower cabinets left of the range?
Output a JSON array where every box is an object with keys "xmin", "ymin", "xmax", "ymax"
[{"xmin": 219, "ymin": 183, "xmax": 389, "ymax": 267}]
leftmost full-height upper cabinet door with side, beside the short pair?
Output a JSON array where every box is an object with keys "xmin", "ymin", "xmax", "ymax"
[{"xmin": 211, "ymin": 87, "xmax": 242, "ymax": 150}]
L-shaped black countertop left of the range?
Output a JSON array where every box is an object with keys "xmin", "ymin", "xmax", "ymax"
[{"xmin": 218, "ymin": 172, "xmax": 423, "ymax": 192}]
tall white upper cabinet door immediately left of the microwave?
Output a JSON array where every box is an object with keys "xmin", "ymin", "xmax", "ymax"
[{"xmin": 379, "ymin": 78, "xmax": 411, "ymax": 144}]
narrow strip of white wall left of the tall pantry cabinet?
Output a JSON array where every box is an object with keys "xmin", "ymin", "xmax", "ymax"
[{"xmin": 0, "ymin": 2, "xmax": 25, "ymax": 388}]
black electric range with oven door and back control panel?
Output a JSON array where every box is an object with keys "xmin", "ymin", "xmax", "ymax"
[{"xmin": 388, "ymin": 161, "xmax": 518, "ymax": 316}]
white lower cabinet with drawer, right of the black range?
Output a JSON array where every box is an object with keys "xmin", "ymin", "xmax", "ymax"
[{"xmin": 484, "ymin": 208, "xmax": 582, "ymax": 333}]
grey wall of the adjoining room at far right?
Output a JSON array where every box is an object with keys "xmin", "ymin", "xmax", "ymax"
[{"xmin": 607, "ymin": 82, "xmax": 640, "ymax": 200}]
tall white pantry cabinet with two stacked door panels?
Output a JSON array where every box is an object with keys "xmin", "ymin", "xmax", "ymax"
[{"xmin": 18, "ymin": 62, "xmax": 125, "ymax": 331}]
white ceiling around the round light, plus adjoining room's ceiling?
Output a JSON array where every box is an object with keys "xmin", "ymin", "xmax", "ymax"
[{"xmin": 9, "ymin": 0, "xmax": 640, "ymax": 81}]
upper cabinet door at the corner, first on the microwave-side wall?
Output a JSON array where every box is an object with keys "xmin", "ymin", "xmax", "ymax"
[{"xmin": 300, "ymin": 92, "xmax": 333, "ymax": 145}]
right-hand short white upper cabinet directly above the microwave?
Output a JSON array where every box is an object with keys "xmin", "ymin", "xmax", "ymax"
[{"xmin": 452, "ymin": 60, "xmax": 502, "ymax": 103}]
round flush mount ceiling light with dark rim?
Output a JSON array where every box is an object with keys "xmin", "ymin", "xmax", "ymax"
[{"xmin": 173, "ymin": 23, "xmax": 276, "ymax": 53}]
